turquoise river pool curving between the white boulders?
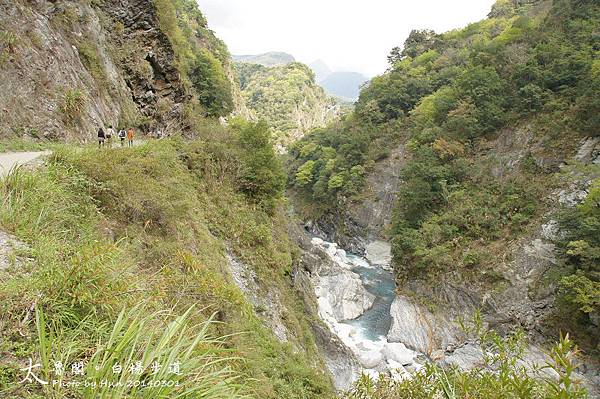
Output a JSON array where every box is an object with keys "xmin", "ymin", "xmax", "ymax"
[{"xmin": 344, "ymin": 255, "xmax": 396, "ymax": 341}]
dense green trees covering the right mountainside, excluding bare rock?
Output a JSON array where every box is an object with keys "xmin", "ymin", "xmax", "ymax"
[{"xmin": 290, "ymin": 0, "xmax": 600, "ymax": 347}]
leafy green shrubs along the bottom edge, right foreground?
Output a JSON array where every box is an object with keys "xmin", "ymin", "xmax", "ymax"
[{"xmin": 344, "ymin": 322, "xmax": 587, "ymax": 399}]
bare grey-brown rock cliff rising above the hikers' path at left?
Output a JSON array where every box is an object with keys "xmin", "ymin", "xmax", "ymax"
[{"xmin": 0, "ymin": 0, "xmax": 246, "ymax": 141}]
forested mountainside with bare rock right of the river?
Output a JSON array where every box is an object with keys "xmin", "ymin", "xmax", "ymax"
[{"xmin": 289, "ymin": 0, "xmax": 600, "ymax": 390}]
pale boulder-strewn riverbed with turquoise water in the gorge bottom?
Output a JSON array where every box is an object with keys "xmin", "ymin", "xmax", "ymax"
[{"xmin": 311, "ymin": 238, "xmax": 426, "ymax": 380}]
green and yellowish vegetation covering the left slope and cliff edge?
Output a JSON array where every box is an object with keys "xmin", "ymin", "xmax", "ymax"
[{"xmin": 0, "ymin": 0, "xmax": 333, "ymax": 399}]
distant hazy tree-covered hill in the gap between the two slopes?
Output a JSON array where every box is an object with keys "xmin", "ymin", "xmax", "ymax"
[{"xmin": 236, "ymin": 62, "xmax": 345, "ymax": 146}]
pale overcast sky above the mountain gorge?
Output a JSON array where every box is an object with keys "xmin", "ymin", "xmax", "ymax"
[{"xmin": 197, "ymin": 0, "xmax": 494, "ymax": 77}]
